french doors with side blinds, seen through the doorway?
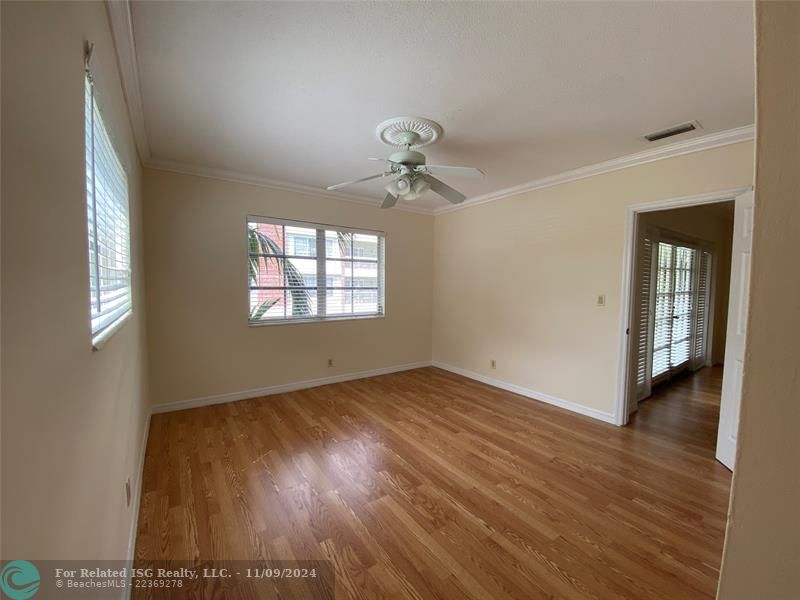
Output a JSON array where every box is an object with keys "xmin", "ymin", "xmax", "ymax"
[{"xmin": 634, "ymin": 230, "xmax": 713, "ymax": 400}]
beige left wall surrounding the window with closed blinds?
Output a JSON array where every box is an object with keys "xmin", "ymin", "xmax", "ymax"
[{"xmin": 2, "ymin": 2, "xmax": 147, "ymax": 559}]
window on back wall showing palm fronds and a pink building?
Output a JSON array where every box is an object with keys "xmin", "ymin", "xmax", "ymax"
[{"xmin": 247, "ymin": 216, "xmax": 385, "ymax": 324}]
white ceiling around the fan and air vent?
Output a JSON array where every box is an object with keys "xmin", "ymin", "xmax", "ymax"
[{"xmin": 132, "ymin": 2, "xmax": 754, "ymax": 207}]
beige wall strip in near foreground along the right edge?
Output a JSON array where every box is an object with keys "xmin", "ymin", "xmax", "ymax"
[{"xmin": 719, "ymin": 2, "xmax": 800, "ymax": 600}]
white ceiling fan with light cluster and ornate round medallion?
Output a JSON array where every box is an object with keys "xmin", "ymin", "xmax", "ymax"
[{"xmin": 328, "ymin": 117, "xmax": 483, "ymax": 208}]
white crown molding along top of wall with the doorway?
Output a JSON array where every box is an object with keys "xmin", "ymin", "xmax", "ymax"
[{"xmin": 433, "ymin": 125, "xmax": 755, "ymax": 215}]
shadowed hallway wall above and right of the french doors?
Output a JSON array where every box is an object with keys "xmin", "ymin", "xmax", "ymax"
[{"xmin": 634, "ymin": 202, "xmax": 733, "ymax": 364}]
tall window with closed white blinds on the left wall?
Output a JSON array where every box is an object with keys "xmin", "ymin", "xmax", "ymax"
[{"xmin": 84, "ymin": 76, "xmax": 131, "ymax": 347}]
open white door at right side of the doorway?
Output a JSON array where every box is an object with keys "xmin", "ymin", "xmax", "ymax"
[{"xmin": 716, "ymin": 191, "xmax": 754, "ymax": 470}]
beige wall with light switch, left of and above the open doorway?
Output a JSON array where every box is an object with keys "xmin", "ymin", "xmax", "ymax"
[{"xmin": 433, "ymin": 143, "xmax": 753, "ymax": 414}]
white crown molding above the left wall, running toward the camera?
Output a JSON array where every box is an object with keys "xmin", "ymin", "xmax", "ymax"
[{"xmin": 106, "ymin": 0, "xmax": 150, "ymax": 163}]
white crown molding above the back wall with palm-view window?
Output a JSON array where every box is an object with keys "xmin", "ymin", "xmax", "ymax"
[{"xmin": 144, "ymin": 160, "xmax": 433, "ymax": 215}]
